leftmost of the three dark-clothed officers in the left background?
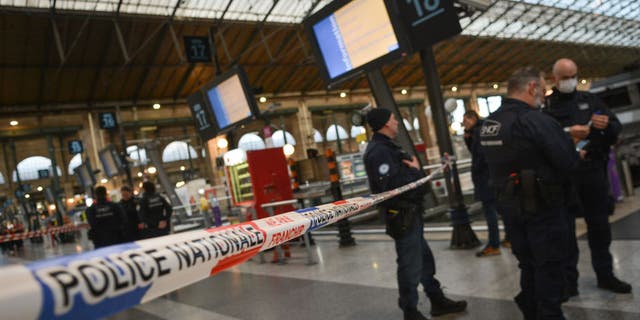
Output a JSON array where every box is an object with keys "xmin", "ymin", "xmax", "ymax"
[{"xmin": 87, "ymin": 186, "xmax": 127, "ymax": 249}]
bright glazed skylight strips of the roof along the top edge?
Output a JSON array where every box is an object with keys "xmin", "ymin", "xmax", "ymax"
[{"xmin": 0, "ymin": 0, "xmax": 640, "ymax": 47}]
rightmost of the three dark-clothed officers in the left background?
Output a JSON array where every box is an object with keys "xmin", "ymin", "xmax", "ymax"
[{"xmin": 138, "ymin": 181, "xmax": 173, "ymax": 239}]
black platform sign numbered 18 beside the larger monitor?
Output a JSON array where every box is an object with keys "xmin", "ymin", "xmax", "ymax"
[{"xmin": 385, "ymin": 0, "xmax": 462, "ymax": 52}]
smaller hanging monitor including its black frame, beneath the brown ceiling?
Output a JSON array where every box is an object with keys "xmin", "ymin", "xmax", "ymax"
[{"xmin": 200, "ymin": 66, "xmax": 260, "ymax": 134}]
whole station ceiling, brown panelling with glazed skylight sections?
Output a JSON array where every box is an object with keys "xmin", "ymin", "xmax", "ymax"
[{"xmin": 0, "ymin": 0, "xmax": 640, "ymax": 115}]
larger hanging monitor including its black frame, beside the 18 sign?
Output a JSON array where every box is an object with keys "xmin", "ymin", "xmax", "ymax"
[{"xmin": 304, "ymin": 0, "xmax": 404, "ymax": 83}]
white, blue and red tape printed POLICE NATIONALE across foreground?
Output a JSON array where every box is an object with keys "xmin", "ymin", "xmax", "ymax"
[{"xmin": 0, "ymin": 166, "xmax": 444, "ymax": 319}]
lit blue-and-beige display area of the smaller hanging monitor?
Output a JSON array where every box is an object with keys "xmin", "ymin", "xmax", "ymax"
[{"xmin": 207, "ymin": 74, "xmax": 252, "ymax": 130}]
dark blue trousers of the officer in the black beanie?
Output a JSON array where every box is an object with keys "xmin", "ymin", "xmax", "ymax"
[{"xmin": 395, "ymin": 215, "xmax": 442, "ymax": 310}]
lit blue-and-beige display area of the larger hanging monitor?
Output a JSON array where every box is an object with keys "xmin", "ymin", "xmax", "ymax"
[{"xmin": 313, "ymin": 0, "xmax": 399, "ymax": 79}]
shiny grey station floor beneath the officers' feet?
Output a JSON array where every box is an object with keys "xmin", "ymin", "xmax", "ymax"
[{"xmin": 0, "ymin": 190, "xmax": 640, "ymax": 320}]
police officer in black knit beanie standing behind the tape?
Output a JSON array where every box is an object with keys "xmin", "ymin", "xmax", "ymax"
[{"xmin": 364, "ymin": 108, "xmax": 467, "ymax": 320}]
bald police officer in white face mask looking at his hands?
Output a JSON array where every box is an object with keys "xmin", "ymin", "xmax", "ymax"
[{"xmin": 543, "ymin": 58, "xmax": 631, "ymax": 298}]
